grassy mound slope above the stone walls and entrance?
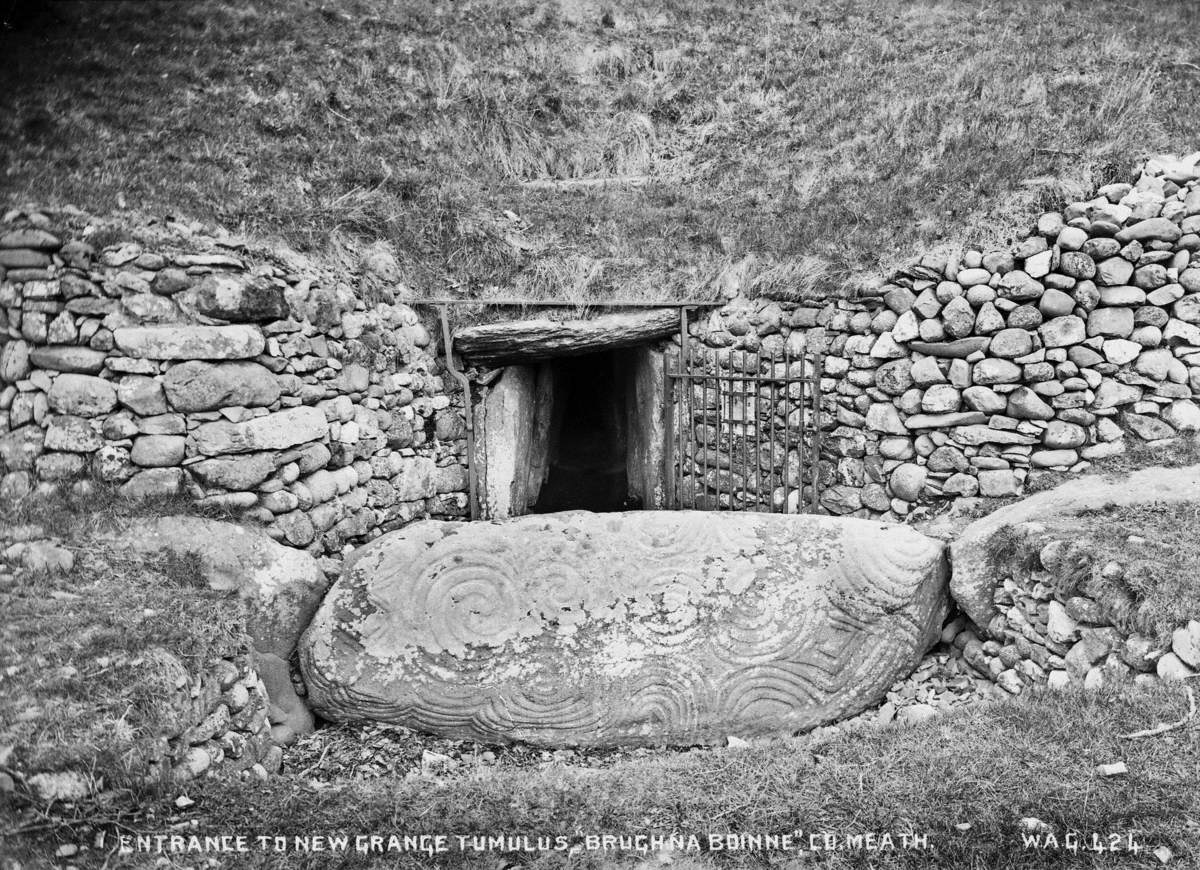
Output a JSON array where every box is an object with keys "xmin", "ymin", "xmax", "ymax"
[{"xmin": 0, "ymin": 0, "xmax": 1200, "ymax": 300}]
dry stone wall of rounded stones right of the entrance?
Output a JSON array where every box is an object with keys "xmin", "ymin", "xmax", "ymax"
[{"xmin": 685, "ymin": 155, "xmax": 1200, "ymax": 520}]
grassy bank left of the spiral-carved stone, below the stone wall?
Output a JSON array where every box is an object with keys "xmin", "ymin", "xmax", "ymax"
[{"xmin": 0, "ymin": 492, "xmax": 248, "ymax": 790}]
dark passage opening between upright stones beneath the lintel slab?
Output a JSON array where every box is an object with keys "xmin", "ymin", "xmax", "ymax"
[{"xmin": 530, "ymin": 350, "xmax": 641, "ymax": 514}]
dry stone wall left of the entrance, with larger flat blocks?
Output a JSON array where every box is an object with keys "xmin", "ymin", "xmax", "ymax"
[{"xmin": 0, "ymin": 210, "xmax": 467, "ymax": 564}]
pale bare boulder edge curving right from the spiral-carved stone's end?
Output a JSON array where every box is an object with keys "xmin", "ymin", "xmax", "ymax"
[{"xmin": 950, "ymin": 466, "xmax": 1200, "ymax": 628}]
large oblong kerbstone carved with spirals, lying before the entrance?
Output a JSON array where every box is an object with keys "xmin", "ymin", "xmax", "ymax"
[{"xmin": 298, "ymin": 511, "xmax": 948, "ymax": 746}]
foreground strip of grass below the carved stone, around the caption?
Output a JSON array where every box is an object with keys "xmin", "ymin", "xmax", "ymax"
[{"xmin": 10, "ymin": 686, "xmax": 1200, "ymax": 870}]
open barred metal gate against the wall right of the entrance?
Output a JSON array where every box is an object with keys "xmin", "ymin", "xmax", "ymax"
[{"xmin": 662, "ymin": 310, "xmax": 822, "ymax": 514}]
